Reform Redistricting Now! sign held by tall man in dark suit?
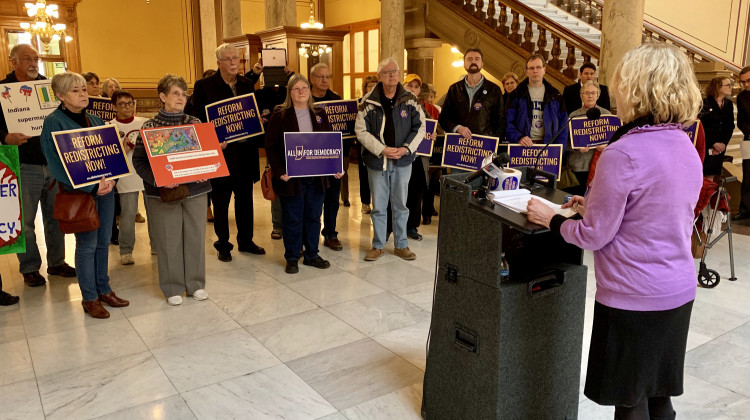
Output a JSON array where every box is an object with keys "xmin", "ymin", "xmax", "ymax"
[{"xmin": 206, "ymin": 93, "xmax": 263, "ymax": 143}]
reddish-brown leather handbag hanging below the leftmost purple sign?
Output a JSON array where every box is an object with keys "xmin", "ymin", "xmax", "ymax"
[{"xmin": 52, "ymin": 183, "xmax": 101, "ymax": 233}]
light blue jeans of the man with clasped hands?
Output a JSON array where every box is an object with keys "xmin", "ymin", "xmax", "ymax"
[{"xmin": 367, "ymin": 159, "xmax": 411, "ymax": 249}]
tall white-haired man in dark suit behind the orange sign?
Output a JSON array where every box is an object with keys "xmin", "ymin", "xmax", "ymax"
[{"xmin": 193, "ymin": 44, "xmax": 266, "ymax": 262}]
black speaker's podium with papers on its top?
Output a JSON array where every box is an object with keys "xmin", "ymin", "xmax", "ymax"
[{"xmin": 422, "ymin": 174, "xmax": 586, "ymax": 420}]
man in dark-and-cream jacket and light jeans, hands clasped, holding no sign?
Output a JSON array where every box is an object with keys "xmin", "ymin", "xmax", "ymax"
[{"xmin": 354, "ymin": 58, "xmax": 425, "ymax": 261}]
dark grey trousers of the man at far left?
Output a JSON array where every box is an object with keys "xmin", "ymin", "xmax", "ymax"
[{"xmin": 18, "ymin": 163, "xmax": 65, "ymax": 274}]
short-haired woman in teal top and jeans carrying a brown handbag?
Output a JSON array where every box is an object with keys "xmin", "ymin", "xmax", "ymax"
[{"xmin": 41, "ymin": 73, "xmax": 129, "ymax": 318}]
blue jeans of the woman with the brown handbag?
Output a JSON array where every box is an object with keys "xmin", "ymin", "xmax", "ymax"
[{"xmin": 75, "ymin": 192, "xmax": 115, "ymax": 301}]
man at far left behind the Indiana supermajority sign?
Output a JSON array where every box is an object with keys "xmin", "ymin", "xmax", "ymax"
[{"xmin": 0, "ymin": 44, "xmax": 76, "ymax": 287}]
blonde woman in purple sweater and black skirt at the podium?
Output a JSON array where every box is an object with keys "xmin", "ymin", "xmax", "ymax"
[{"xmin": 528, "ymin": 44, "xmax": 703, "ymax": 420}]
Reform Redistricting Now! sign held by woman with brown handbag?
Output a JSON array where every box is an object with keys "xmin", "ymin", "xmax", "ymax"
[{"xmin": 52, "ymin": 125, "xmax": 130, "ymax": 188}]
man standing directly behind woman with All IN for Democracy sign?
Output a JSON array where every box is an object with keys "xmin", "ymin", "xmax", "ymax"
[{"xmin": 310, "ymin": 63, "xmax": 346, "ymax": 251}]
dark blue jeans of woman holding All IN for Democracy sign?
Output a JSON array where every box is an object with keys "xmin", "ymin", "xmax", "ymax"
[{"xmin": 279, "ymin": 177, "xmax": 325, "ymax": 261}]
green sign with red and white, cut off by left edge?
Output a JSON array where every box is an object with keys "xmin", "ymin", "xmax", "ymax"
[{"xmin": 0, "ymin": 146, "xmax": 26, "ymax": 255}]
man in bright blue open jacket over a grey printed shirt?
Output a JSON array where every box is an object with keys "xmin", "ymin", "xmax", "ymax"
[{"xmin": 505, "ymin": 54, "xmax": 568, "ymax": 146}]
